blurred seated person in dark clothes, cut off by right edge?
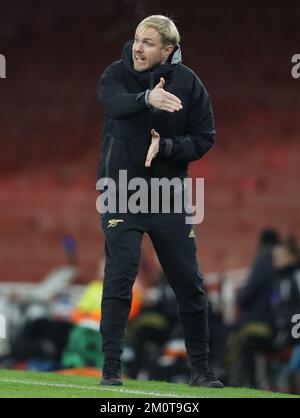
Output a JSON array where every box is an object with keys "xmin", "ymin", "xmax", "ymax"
[{"xmin": 255, "ymin": 237, "xmax": 300, "ymax": 393}]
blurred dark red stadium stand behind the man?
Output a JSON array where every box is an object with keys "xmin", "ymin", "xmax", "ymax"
[{"xmin": 0, "ymin": 0, "xmax": 300, "ymax": 281}]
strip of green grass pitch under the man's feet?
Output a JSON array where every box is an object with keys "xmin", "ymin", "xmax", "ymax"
[{"xmin": 0, "ymin": 370, "xmax": 300, "ymax": 399}]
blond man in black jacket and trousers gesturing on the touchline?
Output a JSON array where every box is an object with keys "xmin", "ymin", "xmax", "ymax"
[{"xmin": 98, "ymin": 15, "xmax": 223, "ymax": 388}]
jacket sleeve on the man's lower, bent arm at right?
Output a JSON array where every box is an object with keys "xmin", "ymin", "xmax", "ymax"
[{"xmin": 159, "ymin": 75, "xmax": 215, "ymax": 163}]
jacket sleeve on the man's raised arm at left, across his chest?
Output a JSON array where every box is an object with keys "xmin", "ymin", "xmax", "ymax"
[{"xmin": 98, "ymin": 65, "xmax": 148, "ymax": 119}]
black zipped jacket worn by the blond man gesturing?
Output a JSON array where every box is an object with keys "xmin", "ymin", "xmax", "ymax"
[{"xmin": 98, "ymin": 41, "xmax": 215, "ymax": 188}]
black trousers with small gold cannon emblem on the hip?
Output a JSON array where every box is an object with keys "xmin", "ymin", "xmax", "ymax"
[{"xmin": 100, "ymin": 213, "xmax": 209, "ymax": 367}]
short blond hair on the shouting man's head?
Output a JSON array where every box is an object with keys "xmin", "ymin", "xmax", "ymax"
[{"xmin": 136, "ymin": 15, "xmax": 180, "ymax": 46}]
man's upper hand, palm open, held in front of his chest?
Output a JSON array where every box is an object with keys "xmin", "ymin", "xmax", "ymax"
[{"xmin": 148, "ymin": 78, "xmax": 182, "ymax": 113}]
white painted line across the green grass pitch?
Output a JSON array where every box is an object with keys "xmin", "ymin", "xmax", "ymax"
[{"xmin": 0, "ymin": 379, "xmax": 195, "ymax": 398}]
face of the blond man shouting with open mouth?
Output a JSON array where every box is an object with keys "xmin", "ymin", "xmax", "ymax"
[{"xmin": 132, "ymin": 28, "xmax": 173, "ymax": 72}]
